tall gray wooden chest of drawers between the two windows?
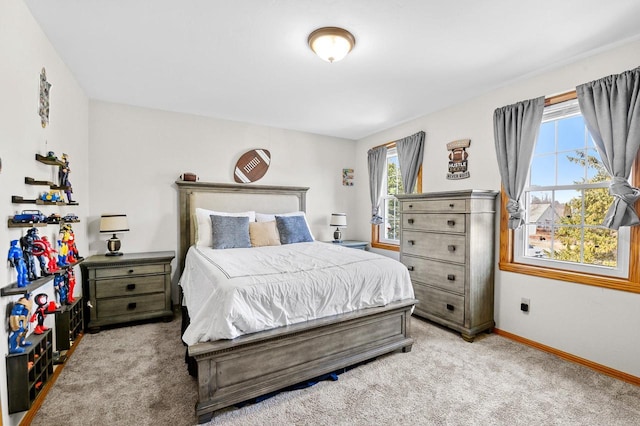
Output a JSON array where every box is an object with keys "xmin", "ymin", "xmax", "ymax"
[{"xmin": 397, "ymin": 190, "xmax": 498, "ymax": 341}]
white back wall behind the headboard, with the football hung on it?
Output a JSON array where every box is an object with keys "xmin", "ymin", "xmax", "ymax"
[{"xmin": 88, "ymin": 101, "xmax": 358, "ymax": 301}]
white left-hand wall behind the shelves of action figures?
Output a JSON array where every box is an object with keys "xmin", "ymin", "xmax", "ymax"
[{"xmin": 0, "ymin": 0, "xmax": 89, "ymax": 425}]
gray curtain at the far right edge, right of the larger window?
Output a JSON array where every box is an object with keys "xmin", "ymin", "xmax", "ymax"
[{"xmin": 576, "ymin": 67, "xmax": 640, "ymax": 229}]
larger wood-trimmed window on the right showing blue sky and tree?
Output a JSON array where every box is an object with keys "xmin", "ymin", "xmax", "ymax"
[{"xmin": 500, "ymin": 92, "xmax": 640, "ymax": 292}]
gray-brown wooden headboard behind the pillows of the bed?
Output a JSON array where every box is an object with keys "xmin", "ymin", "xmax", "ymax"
[{"xmin": 176, "ymin": 180, "xmax": 309, "ymax": 271}]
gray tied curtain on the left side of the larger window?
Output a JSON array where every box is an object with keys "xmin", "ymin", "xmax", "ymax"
[{"xmin": 493, "ymin": 96, "xmax": 544, "ymax": 229}]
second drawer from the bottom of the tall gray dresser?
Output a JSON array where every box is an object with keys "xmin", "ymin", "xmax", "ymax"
[{"xmin": 400, "ymin": 254, "xmax": 465, "ymax": 294}]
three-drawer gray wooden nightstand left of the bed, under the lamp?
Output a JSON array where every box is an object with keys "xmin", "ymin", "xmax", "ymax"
[{"xmin": 80, "ymin": 251, "xmax": 175, "ymax": 333}]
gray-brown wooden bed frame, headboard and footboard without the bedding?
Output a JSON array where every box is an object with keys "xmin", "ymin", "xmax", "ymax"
[{"xmin": 176, "ymin": 181, "xmax": 417, "ymax": 423}]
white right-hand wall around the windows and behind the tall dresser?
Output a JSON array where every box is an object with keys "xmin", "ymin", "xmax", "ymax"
[{"xmin": 352, "ymin": 37, "xmax": 640, "ymax": 377}]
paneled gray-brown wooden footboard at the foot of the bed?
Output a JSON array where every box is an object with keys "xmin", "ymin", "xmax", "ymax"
[{"xmin": 189, "ymin": 299, "xmax": 417, "ymax": 423}]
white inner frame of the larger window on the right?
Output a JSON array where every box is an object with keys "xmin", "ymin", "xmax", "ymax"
[{"xmin": 513, "ymin": 99, "xmax": 631, "ymax": 278}]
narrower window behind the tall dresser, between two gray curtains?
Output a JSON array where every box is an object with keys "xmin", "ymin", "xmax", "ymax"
[{"xmin": 371, "ymin": 144, "xmax": 422, "ymax": 251}]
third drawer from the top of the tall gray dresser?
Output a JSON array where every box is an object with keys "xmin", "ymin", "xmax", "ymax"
[{"xmin": 402, "ymin": 230, "xmax": 466, "ymax": 263}]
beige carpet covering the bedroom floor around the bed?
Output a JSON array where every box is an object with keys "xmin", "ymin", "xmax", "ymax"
[{"xmin": 32, "ymin": 318, "xmax": 640, "ymax": 426}]
